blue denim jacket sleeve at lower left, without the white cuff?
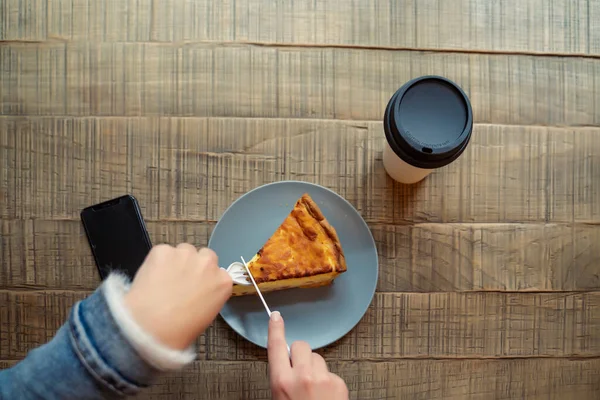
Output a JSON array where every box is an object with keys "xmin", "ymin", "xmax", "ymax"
[{"xmin": 0, "ymin": 282, "xmax": 159, "ymax": 400}]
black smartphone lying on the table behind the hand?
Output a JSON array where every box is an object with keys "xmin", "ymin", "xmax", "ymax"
[{"xmin": 81, "ymin": 195, "xmax": 152, "ymax": 280}]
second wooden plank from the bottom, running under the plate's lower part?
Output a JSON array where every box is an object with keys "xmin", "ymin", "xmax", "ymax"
[{"xmin": 0, "ymin": 291, "xmax": 600, "ymax": 360}]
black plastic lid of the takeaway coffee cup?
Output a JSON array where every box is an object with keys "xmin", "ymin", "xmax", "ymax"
[{"xmin": 384, "ymin": 76, "xmax": 473, "ymax": 169}]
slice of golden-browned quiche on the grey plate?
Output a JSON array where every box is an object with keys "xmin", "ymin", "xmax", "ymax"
[{"xmin": 233, "ymin": 194, "xmax": 346, "ymax": 296}]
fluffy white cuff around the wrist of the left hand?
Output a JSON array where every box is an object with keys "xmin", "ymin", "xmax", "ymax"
[{"xmin": 103, "ymin": 272, "xmax": 196, "ymax": 371}]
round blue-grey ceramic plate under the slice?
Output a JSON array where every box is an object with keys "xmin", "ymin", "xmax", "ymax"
[{"xmin": 208, "ymin": 181, "xmax": 378, "ymax": 349}]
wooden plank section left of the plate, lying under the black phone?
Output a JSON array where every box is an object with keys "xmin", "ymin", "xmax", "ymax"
[{"xmin": 0, "ymin": 220, "xmax": 214, "ymax": 290}]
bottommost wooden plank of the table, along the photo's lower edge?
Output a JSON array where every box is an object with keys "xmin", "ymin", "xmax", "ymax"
[{"xmin": 0, "ymin": 359, "xmax": 600, "ymax": 400}]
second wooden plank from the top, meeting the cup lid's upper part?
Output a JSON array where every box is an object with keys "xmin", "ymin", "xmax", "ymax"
[{"xmin": 0, "ymin": 42, "xmax": 600, "ymax": 125}]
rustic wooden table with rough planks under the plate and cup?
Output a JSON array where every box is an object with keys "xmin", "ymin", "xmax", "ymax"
[{"xmin": 0, "ymin": 0, "xmax": 600, "ymax": 400}]
